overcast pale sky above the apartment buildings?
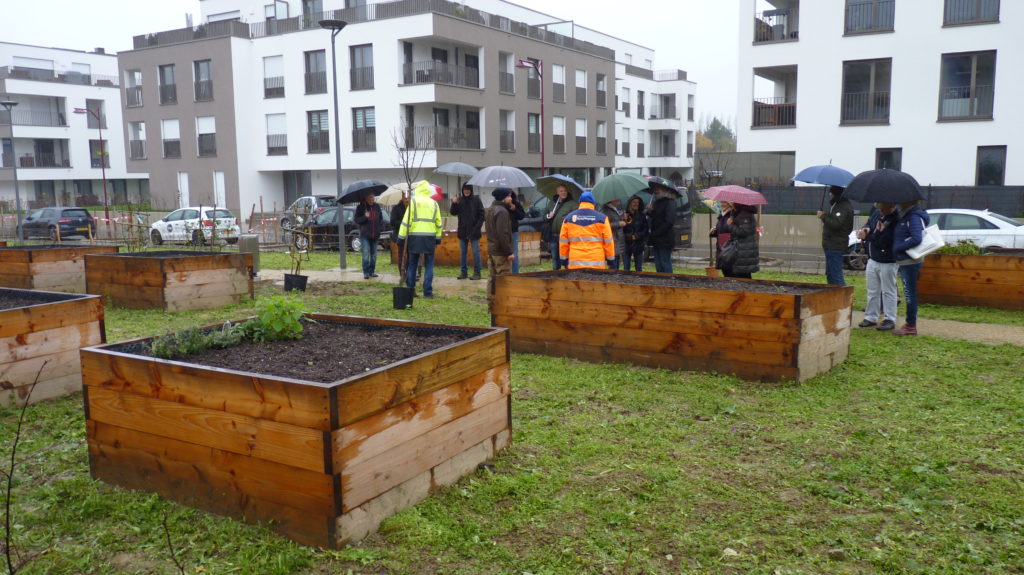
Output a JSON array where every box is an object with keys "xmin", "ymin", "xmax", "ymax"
[{"xmin": 0, "ymin": 0, "xmax": 739, "ymax": 125}]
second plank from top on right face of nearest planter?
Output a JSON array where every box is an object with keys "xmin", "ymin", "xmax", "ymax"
[{"xmin": 333, "ymin": 364, "xmax": 510, "ymax": 471}]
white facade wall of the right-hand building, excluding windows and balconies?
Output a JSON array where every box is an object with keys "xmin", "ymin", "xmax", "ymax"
[{"xmin": 736, "ymin": 0, "xmax": 1024, "ymax": 185}]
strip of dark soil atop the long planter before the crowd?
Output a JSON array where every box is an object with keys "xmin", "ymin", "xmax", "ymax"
[{"xmin": 544, "ymin": 269, "xmax": 825, "ymax": 296}]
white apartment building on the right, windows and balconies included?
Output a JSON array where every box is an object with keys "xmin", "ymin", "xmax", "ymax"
[{"xmin": 737, "ymin": 0, "xmax": 1024, "ymax": 186}]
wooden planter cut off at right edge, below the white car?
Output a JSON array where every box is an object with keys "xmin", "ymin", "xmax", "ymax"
[{"xmin": 918, "ymin": 250, "xmax": 1024, "ymax": 310}]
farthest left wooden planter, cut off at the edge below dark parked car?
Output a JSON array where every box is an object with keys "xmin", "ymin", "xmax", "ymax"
[{"xmin": 0, "ymin": 246, "xmax": 118, "ymax": 294}]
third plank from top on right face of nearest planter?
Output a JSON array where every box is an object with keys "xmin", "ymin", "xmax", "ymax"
[{"xmin": 341, "ymin": 397, "xmax": 510, "ymax": 513}]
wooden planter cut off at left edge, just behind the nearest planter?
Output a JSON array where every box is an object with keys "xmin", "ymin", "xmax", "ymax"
[{"xmin": 0, "ymin": 288, "xmax": 106, "ymax": 405}]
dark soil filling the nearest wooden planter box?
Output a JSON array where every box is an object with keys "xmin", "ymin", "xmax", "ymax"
[{"xmin": 111, "ymin": 321, "xmax": 480, "ymax": 384}]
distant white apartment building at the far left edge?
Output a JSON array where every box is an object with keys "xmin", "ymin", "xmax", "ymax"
[{"xmin": 0, "ymin": 42, "xmax": 148, "ymax": 213}]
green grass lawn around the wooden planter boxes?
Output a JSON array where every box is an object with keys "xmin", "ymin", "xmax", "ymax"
[{"xmin": 0, "ymin": 254, "xmax": 1024, "ymax": 575}]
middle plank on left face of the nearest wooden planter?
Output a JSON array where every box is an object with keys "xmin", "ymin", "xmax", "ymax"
[{"xmin": 87, "ymin": 388, "xmax": 327, "ymax": 473}]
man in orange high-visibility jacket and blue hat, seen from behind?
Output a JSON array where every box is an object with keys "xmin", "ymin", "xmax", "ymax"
[{"xmin": 558, "ymin": 191, "xmax": 615, "ymax": 269}]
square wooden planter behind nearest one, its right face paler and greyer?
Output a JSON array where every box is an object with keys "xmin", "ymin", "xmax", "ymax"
[{"xmin": 85, "ymin": 251, "xmax": 253, "ymax": 311}]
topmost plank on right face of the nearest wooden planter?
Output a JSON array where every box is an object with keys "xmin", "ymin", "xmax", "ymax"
[{"xmin": 338, "ymin": 330, "xmax": 508, "ymax": 427}]
